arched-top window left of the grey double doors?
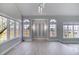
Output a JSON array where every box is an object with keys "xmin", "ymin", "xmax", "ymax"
[{"xmin": 23, "ymin": 19, "xmax": 30, "ymax": 37}]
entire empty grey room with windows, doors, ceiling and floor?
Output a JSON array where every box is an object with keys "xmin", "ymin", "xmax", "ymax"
[{"xmin": 0, "ymin": 3, "xmax": 79, "ymax": 55}]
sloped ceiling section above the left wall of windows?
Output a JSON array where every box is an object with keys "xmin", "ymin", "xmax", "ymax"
[{"xmin": 0, "ymin": 3, "xmax": 21, "ymax": 19}]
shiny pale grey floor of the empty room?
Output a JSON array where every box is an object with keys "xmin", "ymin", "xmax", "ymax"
[{"xmin": 7, "ymin": 41, "xmax": 79, "ymax": 55}]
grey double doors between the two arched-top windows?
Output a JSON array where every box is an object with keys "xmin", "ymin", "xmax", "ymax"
[{"xmin": 32, "ymin": 19, "xmax": 48, "ymax": 40}]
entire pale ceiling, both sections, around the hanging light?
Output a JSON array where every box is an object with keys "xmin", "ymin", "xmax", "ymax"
[{"xmin": 0, "ymin": 3, "xmax": 79, "ymax": 19}]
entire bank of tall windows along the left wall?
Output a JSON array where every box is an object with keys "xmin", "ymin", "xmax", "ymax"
[{"xmin": 0, "ymin": 16, "xmax": 20, "ymax": 44}]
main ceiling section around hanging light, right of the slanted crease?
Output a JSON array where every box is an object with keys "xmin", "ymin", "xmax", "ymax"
[{"xmin": 17, "ymin": 3, "xmax": 79, "ymax": 16}]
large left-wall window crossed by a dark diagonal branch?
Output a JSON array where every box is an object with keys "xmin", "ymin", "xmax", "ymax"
[{"xmin": 0, "ymin": 16, "xmax": 7, "ymax": 43}]
